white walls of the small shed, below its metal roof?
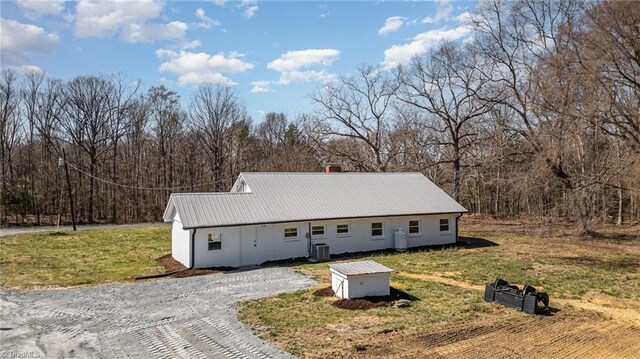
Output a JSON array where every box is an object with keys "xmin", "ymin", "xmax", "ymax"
[{"xmin": 331, "ymin": 270, "xmax": 390, "ymax": 299}]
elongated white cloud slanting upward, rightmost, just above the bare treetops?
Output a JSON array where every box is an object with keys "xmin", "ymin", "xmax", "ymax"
[{"xmin": 382, "ymin": 26, "xmax": 471, "ymax": 68}]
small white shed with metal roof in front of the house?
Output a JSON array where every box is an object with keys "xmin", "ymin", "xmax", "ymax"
[{"xmin": 329, "ymin": 261, "xmax": 393, "ymax": 299}]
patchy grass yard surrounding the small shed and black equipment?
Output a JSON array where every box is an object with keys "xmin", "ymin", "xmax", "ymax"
[{"xmin": 240, "ymin": 219, "xmax": 640, "ymax": 357}]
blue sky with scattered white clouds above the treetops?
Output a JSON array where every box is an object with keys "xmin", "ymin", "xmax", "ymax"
[{"xmin": 0, "ymin": 0, "xmax": 475, "ymax": 122}]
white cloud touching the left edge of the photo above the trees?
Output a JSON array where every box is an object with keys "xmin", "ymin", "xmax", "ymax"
[{"xmin": 0, "ymin": 18, "xmax": 59, "ymax": 65}]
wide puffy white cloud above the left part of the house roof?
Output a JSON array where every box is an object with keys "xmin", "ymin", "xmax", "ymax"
[{"xmin": 156, "ymin": 49, "xmax": 254, "ymax": 86}]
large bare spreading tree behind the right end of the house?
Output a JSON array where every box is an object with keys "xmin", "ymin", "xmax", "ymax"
[{"xmin": 397, "ymin": 43, "xmax": 493, "ymax": 201}]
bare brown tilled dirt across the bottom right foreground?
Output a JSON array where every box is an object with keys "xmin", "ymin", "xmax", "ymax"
[{"xmin": 356, "ymin": 312, "xmax": 640, "ymax": 358}]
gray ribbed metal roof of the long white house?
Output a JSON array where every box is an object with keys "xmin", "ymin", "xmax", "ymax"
[{"xmin": 164, "ymin": 172, "xmax": 467, "ymax": 228}]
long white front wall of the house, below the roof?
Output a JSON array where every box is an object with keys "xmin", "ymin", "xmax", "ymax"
[{"xmin": 182, "ymin": 214, "xmax": 456, "ymax": 268}]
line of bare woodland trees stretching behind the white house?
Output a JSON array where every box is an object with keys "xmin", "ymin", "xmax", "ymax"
[{"xmin": 0, "ymin": 0, "xmax": 640, "ymax": 231}]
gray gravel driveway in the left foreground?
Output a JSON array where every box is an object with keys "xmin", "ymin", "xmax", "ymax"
[{"xmin": 0, "ymin": 268, "xmax": 315, "ymax": 358}]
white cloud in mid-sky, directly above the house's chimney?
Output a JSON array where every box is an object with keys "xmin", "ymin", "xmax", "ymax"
[{"xmin": 267, "ymin": 49, "xmax": 340, "ymax": 85}]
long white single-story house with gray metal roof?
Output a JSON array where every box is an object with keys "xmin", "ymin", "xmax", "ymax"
[{"xmin": 164, "ymin": 171, "xmax": 467, "ymax": 268}]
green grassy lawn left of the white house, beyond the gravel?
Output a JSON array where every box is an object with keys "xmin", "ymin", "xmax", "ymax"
[{"xmin": 0, "ymin": 227, "xmax": 171, "ymax": 288}]
